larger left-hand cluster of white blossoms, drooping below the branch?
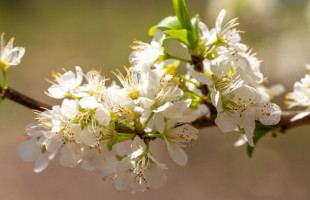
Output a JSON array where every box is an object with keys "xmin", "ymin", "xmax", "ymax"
[{"xmin": 18, "ymin": 36, "xmax": 199, "ymax": 191}]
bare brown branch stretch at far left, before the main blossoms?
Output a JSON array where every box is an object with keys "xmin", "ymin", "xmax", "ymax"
[{"xmin": 0, "ymin": 88, "xmax": 52, "ymax": 111}]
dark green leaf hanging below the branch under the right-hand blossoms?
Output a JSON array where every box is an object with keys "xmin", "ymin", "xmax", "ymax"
[{"xmin": 247, "ymin": 122, "xmax": 275, "ymax": 157}]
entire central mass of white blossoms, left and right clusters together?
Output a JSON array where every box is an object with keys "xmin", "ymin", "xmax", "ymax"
[{"xmin": 18, "ymin": 10, "xmax": 282, "ymax": 191}]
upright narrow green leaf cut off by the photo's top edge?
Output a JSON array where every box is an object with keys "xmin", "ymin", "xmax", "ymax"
[{"xmin": 173, "ymin": 0, "xmax": 193, "ymax": 31}]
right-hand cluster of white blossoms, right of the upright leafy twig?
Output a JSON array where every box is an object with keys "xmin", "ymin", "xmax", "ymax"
[{"xmin": 189, "ymin": 10, "xmax": 283, "ymax": 146}]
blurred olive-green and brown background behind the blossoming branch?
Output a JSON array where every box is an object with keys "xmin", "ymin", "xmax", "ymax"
[{"xmin": 0, "ymin": 0, "xmax": 310, "ymax": 200}]
